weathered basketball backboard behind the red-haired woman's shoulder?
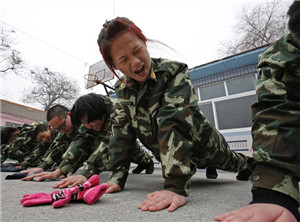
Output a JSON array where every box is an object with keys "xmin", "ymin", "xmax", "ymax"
[{"xmin": 84, "ymin": 60, "xmax": 114, "ymax": 89}]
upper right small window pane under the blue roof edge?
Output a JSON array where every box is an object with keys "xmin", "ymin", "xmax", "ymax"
[{"xmin": 226, "ymin": 74, "xmax": 256, "ymax": 95}]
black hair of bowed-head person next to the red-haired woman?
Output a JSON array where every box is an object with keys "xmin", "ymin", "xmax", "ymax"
[{"xmin": 71, "ymin": 93, "xmax": 106, "ymax": 127}]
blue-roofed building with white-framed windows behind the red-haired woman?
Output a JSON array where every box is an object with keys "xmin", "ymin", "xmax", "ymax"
[{"xmin": 189, "ymin": 46, "xmax": 267, "ymax": 154}]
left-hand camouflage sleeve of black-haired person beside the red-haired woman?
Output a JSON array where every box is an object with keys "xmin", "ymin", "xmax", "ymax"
[{"xmin": 58, "ymin": 125, "xmax": 97, "ymax": 175}]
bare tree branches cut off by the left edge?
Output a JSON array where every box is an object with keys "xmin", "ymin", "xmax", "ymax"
[{"xmin": 0, "ymin": 27, "xmax": 23, "ymax": 76}]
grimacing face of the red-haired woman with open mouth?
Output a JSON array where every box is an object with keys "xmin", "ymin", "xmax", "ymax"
[{"xmin": 110, "ymin": 32, "xmax": 151, "ymax": 83}]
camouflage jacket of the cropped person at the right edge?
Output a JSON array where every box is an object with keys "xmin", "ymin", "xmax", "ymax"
[{"xmin": 250, "ymin": 33, "xmax": 300, "ymax": 202}]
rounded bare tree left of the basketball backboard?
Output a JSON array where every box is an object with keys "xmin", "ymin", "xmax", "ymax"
[{"xmin": 23, "ymin": 68, "xmax": 79, "ymax": 111}]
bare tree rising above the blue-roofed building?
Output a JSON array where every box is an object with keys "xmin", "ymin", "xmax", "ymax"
[{"xmin": 219, "ymin": 0, "xmax": 290, "ymax": 56}]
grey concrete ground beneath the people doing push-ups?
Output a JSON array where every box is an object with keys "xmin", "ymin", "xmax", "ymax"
[{"xmin": 0, "ymin": 168, "xmax": 251, "ymax": 222}]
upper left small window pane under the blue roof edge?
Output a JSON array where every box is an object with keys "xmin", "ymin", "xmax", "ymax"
[{"xmin": 200, "ymin": 82, "xmax": 226, "ymax": 101}]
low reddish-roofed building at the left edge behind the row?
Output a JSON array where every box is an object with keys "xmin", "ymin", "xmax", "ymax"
[{"xmin": 0, "ymin": 99, "xmax": 47, "ymax": 127}]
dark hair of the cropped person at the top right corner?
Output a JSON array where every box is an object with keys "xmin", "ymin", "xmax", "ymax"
[{"xmin": 288, "ymin": 1, "xmax": 300, "ymax": 41}]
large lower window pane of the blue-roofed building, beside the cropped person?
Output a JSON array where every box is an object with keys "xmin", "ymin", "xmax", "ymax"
[{"xmin": 215, "ymin": 95, "xmax": 256, "ymax": 130}]
